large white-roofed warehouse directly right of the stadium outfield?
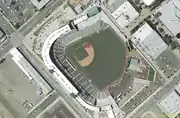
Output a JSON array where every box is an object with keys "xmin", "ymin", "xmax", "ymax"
[{"xmin": 131, "ymin": 23, "xmax": 168, "ymax": 59}]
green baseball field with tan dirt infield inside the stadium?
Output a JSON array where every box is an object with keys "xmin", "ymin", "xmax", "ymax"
[{"xmin": 65, "ymin": 28, "xmax": 126, "ymax": 90}]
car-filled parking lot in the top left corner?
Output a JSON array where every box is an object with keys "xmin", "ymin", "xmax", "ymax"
[{"xmin": 0, "ymin": 0, "xmax": 35, "ymax": 29}]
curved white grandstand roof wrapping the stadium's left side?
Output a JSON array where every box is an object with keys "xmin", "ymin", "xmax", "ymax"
[{"xmin": 42, "ymin": 25, "xmax": 100, "ymax": 112}]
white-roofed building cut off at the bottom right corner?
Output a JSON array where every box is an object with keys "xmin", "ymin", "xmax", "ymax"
[{"xmin": 158, "ymin": 85, "xmax": 180, "ymax": 118}]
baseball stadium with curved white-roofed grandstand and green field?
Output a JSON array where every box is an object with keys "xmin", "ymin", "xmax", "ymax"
[{"xmin": 42, "ymin": 21, "xmax": 127, "ymax": 111}]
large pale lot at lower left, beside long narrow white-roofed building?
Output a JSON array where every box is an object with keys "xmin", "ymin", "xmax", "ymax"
[{"xmin": 0, "ymin": 55, "xmax": 45, "ymax": 117}]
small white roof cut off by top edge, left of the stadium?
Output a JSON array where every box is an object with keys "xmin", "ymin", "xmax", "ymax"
[{"xmin": 30, "ymin": 0, "xmax": 51, "ymax": 10}]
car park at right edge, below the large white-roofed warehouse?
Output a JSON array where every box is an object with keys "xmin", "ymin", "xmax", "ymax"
[{"xmin": 155, "ymin": 49, "xmax": 180, "ymax": 78}]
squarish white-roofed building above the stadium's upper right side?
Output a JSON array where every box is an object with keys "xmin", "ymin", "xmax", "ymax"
[{"xmin": 112, "ymin": 1, "xmax": 139, "ymax": 28}]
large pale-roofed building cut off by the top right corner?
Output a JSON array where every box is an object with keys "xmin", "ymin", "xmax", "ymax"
[{"xmin": 157, "ymin": 0, "xmax": 180, "ymax": 35}]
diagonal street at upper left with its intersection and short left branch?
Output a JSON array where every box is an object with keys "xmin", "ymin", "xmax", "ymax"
[{"xmin": 0, "ymin": 0, "xmax": 66, "ymax": 57}]
